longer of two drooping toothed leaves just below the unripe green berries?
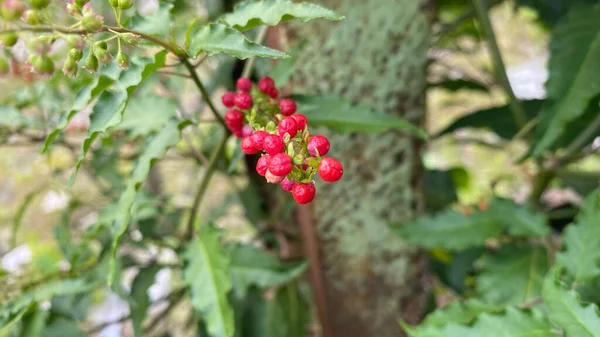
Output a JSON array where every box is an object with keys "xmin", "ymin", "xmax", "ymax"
[{"xmin": 69, "ymin": 51, "xmax": 166, "ymax": 186}]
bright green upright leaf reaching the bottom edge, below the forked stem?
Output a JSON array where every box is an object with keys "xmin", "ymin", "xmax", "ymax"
[{"xmin": 183, "ymin": 226, "xmax": 235, "ymax": 337}]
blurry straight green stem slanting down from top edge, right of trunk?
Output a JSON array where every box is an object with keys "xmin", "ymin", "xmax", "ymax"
[{"xmin": 473, "ymin": 0, "xmax": 527, "ymax": 129}]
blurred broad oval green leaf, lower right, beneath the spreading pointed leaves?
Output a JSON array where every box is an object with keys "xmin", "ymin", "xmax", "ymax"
[{"xmin": 475, "ymin": 246, "xmax": 548, "ymax": 305}]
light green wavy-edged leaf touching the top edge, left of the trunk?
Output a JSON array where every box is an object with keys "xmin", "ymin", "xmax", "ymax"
[{"xmin": 222, "ymin": 0, "xmax": 344, "ymax": 31}]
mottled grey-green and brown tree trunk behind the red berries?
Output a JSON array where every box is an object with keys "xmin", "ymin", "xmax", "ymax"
[{"xmin": 289, "ymin": 0, "xmax": 433, "ymax": 337}]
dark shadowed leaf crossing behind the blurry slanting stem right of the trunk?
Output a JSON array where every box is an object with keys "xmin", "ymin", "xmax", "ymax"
[{"xmin": 436, "ymin": 100, "xmax": 544, "ymax": 139}]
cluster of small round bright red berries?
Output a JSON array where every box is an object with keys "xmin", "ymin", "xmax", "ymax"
[{"xmin": 221, "ymin": 77, "xmax": 344, "ymax": 204}]
